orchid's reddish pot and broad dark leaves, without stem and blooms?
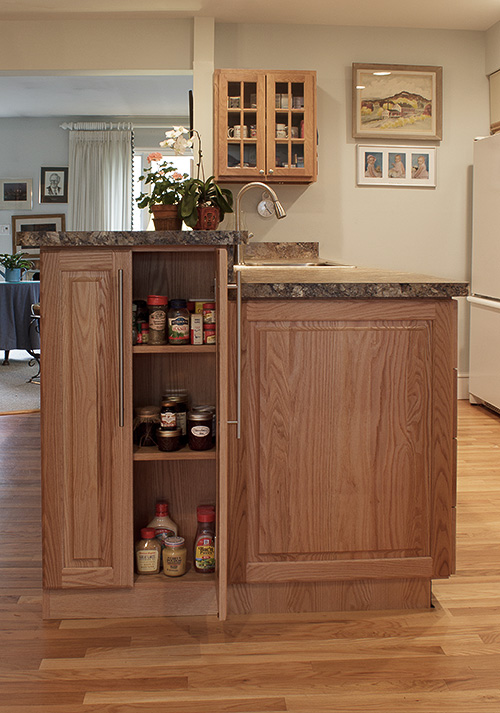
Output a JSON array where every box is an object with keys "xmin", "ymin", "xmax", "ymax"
[{"xmin": 179, "ymin": 176, "xmax": 233, "ymax": 230}]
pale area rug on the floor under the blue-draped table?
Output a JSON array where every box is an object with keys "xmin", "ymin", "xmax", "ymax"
[{"xmin": 0, "ymin": 350, "xmax": 40, "ymax": 413}]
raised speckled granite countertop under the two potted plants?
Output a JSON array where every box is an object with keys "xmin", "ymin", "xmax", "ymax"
[{"xmin": 16, "ymin": 230, "xmax": 248, "ymax": 248}]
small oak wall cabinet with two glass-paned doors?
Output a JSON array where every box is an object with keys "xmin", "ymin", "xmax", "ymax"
[{"xmin": 214, "ymin": 69, "xmax": 317, "ymax": 183}]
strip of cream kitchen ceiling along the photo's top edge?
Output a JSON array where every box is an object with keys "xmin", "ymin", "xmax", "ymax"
[{"xmin": 0, "ymin": 0, "xmax": 500, "ymax": 30}]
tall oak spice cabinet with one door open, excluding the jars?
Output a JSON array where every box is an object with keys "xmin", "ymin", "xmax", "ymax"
[{"xmin": 41, "ymin": 245, "xmax": 228, "ymax": 618}]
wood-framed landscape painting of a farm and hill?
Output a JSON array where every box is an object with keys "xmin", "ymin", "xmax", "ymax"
[{"xmin": 352, "ymin": 63, "xmax": 443, "ymax": 141}]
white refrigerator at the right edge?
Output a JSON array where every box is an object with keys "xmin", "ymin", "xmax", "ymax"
[{"xmin": 467, "ymin": 134, "xmax": 500, "ymax": 411}]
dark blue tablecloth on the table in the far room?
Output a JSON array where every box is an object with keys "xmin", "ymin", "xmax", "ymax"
[{"xmin": 0, "ymin": 281, "xmax": 40, "ymax": 350}]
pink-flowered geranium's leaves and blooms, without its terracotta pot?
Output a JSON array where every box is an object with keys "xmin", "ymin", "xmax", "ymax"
[{"xmin": 137, "ymin": 152, "xmax": 189, "ymax": 213}]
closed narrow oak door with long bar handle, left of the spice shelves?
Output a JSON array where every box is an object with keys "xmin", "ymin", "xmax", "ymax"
[{"xmin": 41, "ymin": 248, "xmax": 133, "ymax": 589}]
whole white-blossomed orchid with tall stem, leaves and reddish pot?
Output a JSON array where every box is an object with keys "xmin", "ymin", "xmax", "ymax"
[{"xmin": 160, "ymin": 126, "xmax": 233, "ymax": 230}]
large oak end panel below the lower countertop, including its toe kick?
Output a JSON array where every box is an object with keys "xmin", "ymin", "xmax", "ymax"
[{"xmin": 228, "ymin": 299, "xmax": 456, "ymax": 613}]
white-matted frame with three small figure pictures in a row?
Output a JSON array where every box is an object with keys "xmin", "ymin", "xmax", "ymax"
[{"xmin": 356, "ymin": 145, "xmax": 436, "ymax": 188}]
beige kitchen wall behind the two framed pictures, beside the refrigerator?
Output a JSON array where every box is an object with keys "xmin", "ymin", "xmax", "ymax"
[{"xmin": 215, "ymin": 25, "xmax": 489, "ymax": 384}]
